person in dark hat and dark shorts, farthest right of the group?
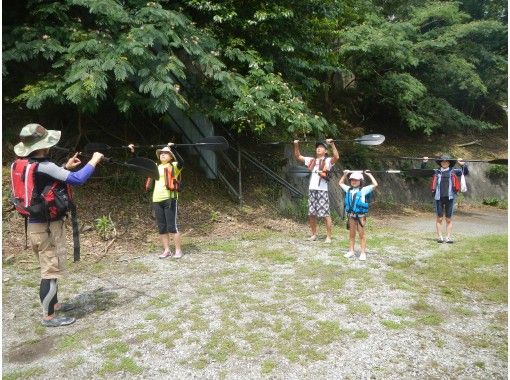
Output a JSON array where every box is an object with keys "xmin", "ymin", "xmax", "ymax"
[{"xmin": 421, "ymin": 155, "xmax": 469, "ymax": 244}]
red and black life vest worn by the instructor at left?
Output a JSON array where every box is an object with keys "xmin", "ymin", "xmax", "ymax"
[{"xmin": 11, "ymin": 158, "xmax": 73, "ymax": 221}]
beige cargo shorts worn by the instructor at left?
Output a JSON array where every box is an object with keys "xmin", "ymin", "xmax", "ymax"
[{"xmin": 27, "ymin": 220, "xmax": 66, "ymax": 279}]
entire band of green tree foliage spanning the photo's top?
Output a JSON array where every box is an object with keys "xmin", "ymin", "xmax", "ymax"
[{"xmin": 3, "ymin": 0, "xmax": 507, "ymax": 134}]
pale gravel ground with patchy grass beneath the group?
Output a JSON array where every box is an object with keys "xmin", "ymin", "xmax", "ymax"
[{"xmin": 2, "ymin": 211, "xmax": 507, "ymax": 379}]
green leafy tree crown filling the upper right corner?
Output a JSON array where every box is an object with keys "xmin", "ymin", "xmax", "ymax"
[{"xmin": 339, "ymin": 2, "xmax": 507, "ymax": 134}]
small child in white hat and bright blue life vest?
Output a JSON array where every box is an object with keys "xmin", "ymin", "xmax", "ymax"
[{"xmin": 338, "ymin": 170, "xmax": 378, "ymax": 261}]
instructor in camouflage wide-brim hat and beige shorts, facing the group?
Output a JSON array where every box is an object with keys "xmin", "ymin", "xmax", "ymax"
[{"xmin": 11, "ymin": 123, "xmax": 103, "ymax": 327}]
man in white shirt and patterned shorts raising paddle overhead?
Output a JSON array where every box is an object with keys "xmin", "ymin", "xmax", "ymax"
[{"xmin": 294, "ymin": 139, "xmax": 340, "ymax": 243}]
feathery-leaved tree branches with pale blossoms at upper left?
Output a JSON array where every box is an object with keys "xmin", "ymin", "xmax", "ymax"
[{"xmin": 3, "ymin": 0, "xmax": 331, "ymax": 136}]
